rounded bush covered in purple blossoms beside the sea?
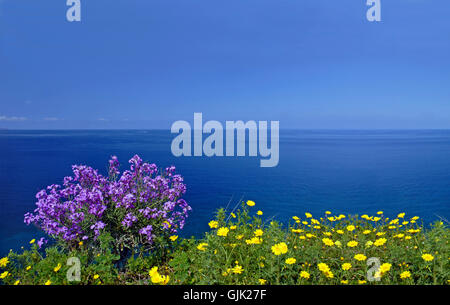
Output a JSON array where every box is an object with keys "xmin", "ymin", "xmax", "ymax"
[{"xmin": 24, "ymin": 155, "xmax": 191, "ymax": 252}]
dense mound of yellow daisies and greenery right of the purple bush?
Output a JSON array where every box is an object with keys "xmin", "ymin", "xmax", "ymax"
[{"xmin": 169, "ymin": 200, "xmax": 450, "ymax": 285}]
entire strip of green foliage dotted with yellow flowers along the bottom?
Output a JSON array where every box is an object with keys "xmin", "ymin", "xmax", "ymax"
[{"xmin": 0, "ymin": 202, "xmax": 450, "ymax": 285}]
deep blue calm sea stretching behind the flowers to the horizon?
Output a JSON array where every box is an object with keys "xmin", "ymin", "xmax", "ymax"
[{"xmin": 0, "ymin": 130, "xmax": 450, "ymax": 255}]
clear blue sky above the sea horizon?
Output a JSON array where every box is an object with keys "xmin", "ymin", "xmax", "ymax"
[{"xmin": 0, "ymin": 0, "xmax": 450, "ymax": 129}]
